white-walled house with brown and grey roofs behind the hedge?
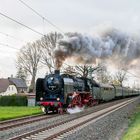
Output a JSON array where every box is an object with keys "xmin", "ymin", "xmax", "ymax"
[{"xmin": 0, "ymin": 77, "xmax": 27, "ymax": 96}]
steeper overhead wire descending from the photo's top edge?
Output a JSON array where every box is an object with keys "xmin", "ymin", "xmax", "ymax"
[{"xmin": 19, "ymin": 0, "xmax": 64, "ymax": 34}]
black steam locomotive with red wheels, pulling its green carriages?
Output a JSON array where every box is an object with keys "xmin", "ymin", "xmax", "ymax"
[{"xmin": 36, "ymin": 70, "xmax": 140, "ymax": 113}]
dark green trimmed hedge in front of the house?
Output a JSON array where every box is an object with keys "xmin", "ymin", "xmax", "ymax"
[{"xmin": 0, "ymin": 95, "xmax": 27, "ymax": 106}]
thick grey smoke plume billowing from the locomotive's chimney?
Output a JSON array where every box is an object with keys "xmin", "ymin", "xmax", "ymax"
[{"xmin": 54, "ymin": 29, "xmax": 140, "ymax": 69}]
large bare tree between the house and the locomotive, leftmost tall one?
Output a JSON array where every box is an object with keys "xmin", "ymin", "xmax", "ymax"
[{"xmin": 17, "ymin": 41, "xmax": 42, "ymax": 92}]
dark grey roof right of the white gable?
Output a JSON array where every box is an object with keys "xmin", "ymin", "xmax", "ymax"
[{"xmin": 8, "ymin": 77, "xmax": 27, "ymax": 88}]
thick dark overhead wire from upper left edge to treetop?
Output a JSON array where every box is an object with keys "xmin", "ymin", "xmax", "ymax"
[{"xmin": 0, "ymin": 12, "xmax": 43, "ymax": 36}]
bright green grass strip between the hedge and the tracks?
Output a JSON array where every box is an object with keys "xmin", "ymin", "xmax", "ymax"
[{"xmin": 0, "ymin": 106, "xmax": 41, "ymax": 121}]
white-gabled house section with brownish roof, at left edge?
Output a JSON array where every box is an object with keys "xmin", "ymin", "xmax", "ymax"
[{"xmin": 0, "ymin": 79, "xmax": 18, "ymax": 96}]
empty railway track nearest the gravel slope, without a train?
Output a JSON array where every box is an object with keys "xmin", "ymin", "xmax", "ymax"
[{"xmin": 9, "ymin": 98, "xmax": 136, "ymax": 140}]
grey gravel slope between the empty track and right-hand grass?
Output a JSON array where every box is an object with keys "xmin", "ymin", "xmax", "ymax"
[{"xmin": 59, "ymin": 97, "xmax": 140, "ymax": 140}]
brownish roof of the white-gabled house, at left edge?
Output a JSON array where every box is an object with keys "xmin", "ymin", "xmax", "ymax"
[{"xmin": 0, "ymin": 79, "xmax": 10, "ymax": 93}]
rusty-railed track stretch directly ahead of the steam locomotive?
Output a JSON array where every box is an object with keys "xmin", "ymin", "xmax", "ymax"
[{"xmin": 0, "ymin": 114, "xmax": 58, "ymax": 131}]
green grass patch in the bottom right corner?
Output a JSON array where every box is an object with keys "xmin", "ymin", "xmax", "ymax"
[{"xmin": 122, "ymin": 105, "xmax": 140, "ymax": 140}]
